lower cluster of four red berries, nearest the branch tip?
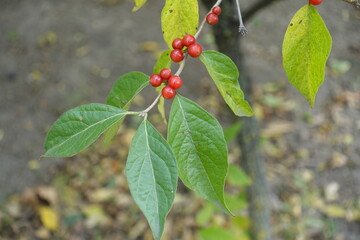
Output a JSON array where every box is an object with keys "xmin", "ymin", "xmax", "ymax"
[{"xmin": 149, "ymin": 68, "xmax": 182, "ymax": 99}]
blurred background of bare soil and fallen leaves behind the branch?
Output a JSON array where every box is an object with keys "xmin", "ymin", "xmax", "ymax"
[{"xmin": 0, "ymin": 0, "xmax": 360, "ymax": 240}]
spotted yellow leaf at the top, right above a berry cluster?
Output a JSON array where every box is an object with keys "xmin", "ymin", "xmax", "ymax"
[{"xmin": 161, "ymin": 0, "xmax": 199, "ymax": 48}]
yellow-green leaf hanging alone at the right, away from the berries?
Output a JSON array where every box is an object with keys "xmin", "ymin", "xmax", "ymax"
[{"xmin": 282, "ymin": 4, "xmax": 332, "ymax": 107}]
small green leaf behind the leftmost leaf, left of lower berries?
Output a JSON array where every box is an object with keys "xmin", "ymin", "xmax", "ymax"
[{"xmin": 106, "ymin": 72, "xmax": 150, "ymax": 110}]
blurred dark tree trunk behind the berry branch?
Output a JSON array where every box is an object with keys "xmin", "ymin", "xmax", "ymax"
[{"xmin": 202, "ymin": 0, "xmax": 274, "ymax": 240}]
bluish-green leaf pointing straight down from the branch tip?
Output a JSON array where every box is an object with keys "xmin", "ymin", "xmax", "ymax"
[{"xmin": 126, "ymin": 121, "xmax": 178, "ymax": 239}]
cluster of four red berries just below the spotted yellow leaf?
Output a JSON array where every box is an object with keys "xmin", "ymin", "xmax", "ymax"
[{"xmin": 170, "ymin": 34, "xmax": 202, "ymax": 62}]
